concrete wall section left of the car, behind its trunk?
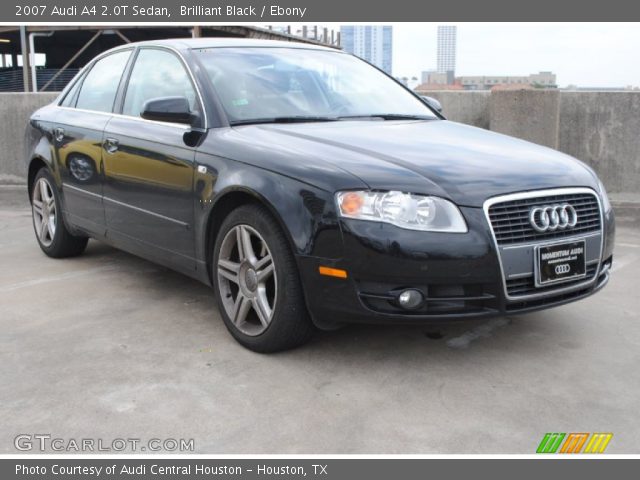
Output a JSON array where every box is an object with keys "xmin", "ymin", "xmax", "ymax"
[{"xmin": 0, "ymin": 93, "xmax": 58, "ymax": 183}]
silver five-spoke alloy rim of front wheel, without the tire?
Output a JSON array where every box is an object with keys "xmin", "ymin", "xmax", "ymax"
[{"xmin": 217, "ymin": 225, "xmax": 278, "ymax": 336}]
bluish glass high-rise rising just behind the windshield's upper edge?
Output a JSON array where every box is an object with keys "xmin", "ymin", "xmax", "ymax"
[{"xmin": 340, "ymin": 25, "xmax": 393, "ymax": 75}]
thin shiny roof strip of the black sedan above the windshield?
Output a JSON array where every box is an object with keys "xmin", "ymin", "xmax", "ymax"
[{"xmin": 121, "ymin": 37, "xmax": 340, "ymax": 51}]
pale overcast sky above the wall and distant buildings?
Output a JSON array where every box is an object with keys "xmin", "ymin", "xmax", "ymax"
[{"xmin": 393, "ymin": 23, "xmax": 640, "ymax": 87}]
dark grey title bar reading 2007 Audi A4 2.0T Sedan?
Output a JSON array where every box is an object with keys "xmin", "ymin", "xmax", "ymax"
[{"xmin": 0, "ymin": 0, "xmax": 640, "ymax": 24}]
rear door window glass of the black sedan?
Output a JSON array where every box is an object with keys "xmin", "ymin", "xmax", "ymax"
[{"xmin": 76, "ymin": 50, "xmax": 131, "ymax": 112}]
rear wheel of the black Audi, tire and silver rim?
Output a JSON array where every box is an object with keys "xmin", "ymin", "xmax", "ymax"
[{"xmin": 31, "ymin": 168, "xmax": 89, "ymax": 258}]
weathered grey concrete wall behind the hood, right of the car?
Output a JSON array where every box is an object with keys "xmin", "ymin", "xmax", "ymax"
[{"xmin": 420, "ymin": 90, "xmax": 640, "ymax": 193}]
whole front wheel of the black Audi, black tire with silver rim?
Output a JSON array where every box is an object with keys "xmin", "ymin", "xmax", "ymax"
[{"xmin": 212, "ymin": 205, "xmax": 315, "ymax": 353}]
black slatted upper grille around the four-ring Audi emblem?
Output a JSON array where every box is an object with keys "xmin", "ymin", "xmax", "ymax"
[{"xmin": 489, "ymin": 193, "xmax": 600, "ymax": 245}]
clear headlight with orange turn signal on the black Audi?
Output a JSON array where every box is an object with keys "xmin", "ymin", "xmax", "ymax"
[{"xmin": 336, "ymin": 191, "xmax": 468, "ymax": 233}]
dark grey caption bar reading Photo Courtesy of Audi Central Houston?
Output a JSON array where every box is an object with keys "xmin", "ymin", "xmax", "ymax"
[{"xmin": 0, "ymin": 457, "xmax": 639, "ymax": 480}]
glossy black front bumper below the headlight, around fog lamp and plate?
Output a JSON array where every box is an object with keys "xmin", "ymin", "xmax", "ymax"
[{"xmin": 298, "ymin": 191, "xmax": 615, "ymax": 329}]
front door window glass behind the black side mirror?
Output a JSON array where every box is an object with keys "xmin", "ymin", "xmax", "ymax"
[{"xmin": 122, "ymin": 48, "xmax": 197, "ymax": 117}]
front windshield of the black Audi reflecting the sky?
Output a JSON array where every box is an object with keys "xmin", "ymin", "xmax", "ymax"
[{"xmin": 196, "ymin": 47, "xmax": 437, "ymax": 124}]
